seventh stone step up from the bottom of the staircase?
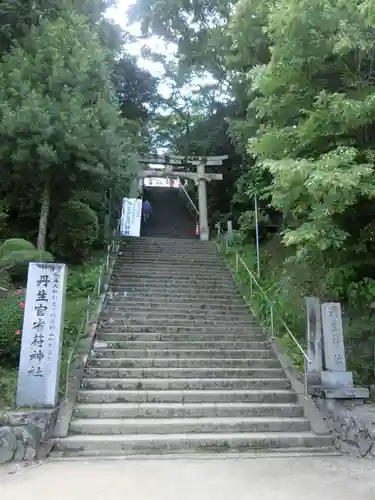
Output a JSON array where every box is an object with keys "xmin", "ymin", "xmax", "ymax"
[{"xmin": 88, "ymin": 357, "xmax": 280, "ymax": 369}]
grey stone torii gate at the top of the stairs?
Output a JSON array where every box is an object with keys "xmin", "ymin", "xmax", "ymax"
[{"xmin": 139, "ymin": 154, "xmax": 228, "ymax": 241}]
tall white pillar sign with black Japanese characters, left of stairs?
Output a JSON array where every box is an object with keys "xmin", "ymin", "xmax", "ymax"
[{"xmin": 16, "ymin": 263, "xmax": 67, "ymax": 407}]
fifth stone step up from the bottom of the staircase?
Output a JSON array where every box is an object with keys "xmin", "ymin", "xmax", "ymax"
[{"xmin": 82, "ymin": 377, "xmax": 290, "ymax": 391}]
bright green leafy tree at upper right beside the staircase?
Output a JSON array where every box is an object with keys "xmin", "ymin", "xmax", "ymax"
[{"xmin": 250, "ymin": 0, "xmax": 375, "ymax": 280}]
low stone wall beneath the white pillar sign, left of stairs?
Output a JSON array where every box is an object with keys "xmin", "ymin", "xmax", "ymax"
[{"xmin": 0, "ymin": 409, "xmax": 57, "ymax": 464}]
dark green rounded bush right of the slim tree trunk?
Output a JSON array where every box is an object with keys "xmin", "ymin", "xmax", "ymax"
[{"xmin": 51, "ymin": 200, "xmax": 99, "ymax": 264}]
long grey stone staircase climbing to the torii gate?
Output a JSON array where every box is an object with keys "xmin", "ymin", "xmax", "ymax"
[{"xmin": 56, "ymin": 238, "xmax": 332, "ymax": 456}]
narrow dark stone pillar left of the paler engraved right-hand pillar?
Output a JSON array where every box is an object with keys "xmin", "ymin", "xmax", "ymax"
[{"xmin": 305, "ymin": 297, "xmax": 323, "ymax": 382}]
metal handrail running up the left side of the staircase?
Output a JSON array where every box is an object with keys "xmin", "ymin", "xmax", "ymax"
[{"xmin": 65, "ymin": 221, "xmax": 120, "ymax": 398}]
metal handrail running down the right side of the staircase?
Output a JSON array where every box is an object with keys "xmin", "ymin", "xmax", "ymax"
[{"xmin": 217, "ymin": 229, "xmax": 311, "ymax": 397}]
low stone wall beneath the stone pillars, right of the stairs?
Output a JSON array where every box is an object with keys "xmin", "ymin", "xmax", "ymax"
[{"xmin": 314, "ymin": 398, "xmax": 375, "ymax": 459}]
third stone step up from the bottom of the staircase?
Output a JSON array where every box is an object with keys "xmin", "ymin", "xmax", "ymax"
[{"xmin": 74, "ymin": 402, "xmax": 303, "ymax": 419}]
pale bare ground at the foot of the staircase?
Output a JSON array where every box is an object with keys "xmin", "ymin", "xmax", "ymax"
[{"xmin": 0, "ymin": 457, "xmax": 375, "ymax": 500}]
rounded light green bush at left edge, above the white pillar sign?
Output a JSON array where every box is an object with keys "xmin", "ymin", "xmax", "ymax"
[{"xmin": 0, "ymin": 238, "xmax": 53, "ymax": 281}]
